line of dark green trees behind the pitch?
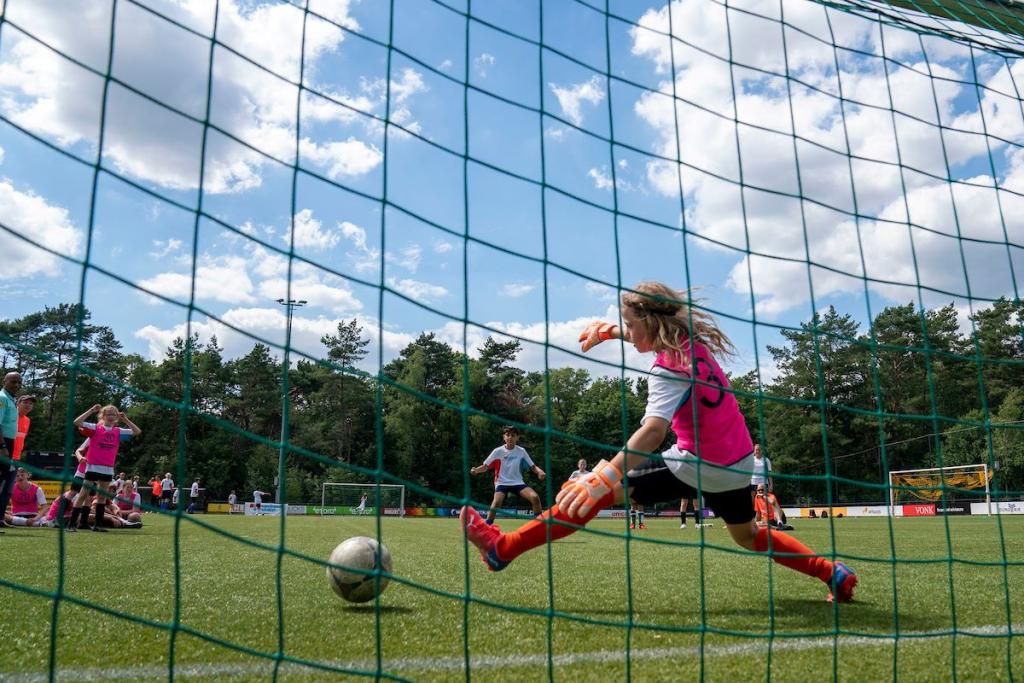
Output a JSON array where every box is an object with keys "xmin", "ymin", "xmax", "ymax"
[{"xmin": 0, "ymin": 299, "xmax": 1024, "ymax": 504}]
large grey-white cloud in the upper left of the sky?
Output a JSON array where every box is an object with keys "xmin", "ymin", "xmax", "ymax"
[{"xmin": 0, "ymin": 0, "xmax": 395, "ymax": 193}]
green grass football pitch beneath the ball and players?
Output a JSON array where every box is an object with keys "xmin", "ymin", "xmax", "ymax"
[{"xmin": 0, "ymin": 514, "xmax": 1024, "ymax": 683}]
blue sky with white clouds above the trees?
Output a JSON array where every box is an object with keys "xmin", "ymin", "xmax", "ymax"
[{"xmin": 0, "ymin": 0, "xmax": 1024, "ymax": 376}]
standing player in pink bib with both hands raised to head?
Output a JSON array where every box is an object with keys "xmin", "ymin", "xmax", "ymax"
[{"xmin": 71, "ymin": 403, "xmax": 142, "ymax": 531}]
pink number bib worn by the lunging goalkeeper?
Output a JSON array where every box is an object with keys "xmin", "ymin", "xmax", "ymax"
[{"xmin": 654, "ymin": 341, "xmax": 754, "ymax": 466}]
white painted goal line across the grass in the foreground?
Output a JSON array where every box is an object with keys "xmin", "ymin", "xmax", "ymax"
[{"xmin": 0, "ymin": 624, "xmax": 1024, "ymax": 683}]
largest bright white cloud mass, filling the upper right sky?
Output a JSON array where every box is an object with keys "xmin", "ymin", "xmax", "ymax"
[{"xmin": 626, "ymin": 0, "xmax": 1024, "ymax": 317}]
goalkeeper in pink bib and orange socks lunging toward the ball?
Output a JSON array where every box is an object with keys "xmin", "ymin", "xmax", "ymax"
[{"xmin": 461, "ymin": 283, "xmax": 857, "ymax": 602}]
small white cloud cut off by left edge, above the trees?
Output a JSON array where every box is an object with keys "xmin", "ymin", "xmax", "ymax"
[{"xmin": 0, "ymin": 179, "xmax": 84, "ymax": 280}]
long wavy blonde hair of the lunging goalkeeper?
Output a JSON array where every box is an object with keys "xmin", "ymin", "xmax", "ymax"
[{"xmin": 622, "ymin": 282, "xmax": 735, "ymax": 360}]
